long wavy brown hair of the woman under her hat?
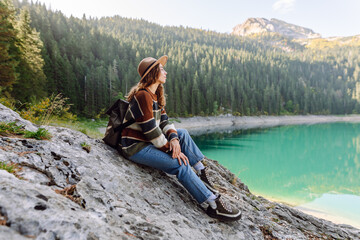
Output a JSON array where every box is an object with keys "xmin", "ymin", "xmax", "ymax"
[{"xmin": 125, "ymin": 64, "xmax": 166, "ymax": 109}]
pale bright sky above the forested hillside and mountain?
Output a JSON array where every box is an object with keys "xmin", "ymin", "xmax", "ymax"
[{"xmin": 34, "ymin": 0, "xmax": 360, "ymax": 37}]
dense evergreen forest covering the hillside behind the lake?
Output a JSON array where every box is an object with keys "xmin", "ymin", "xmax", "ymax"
[{"xmin": 0, "ymin": 0, "xmax": 360, "ymax": 117}]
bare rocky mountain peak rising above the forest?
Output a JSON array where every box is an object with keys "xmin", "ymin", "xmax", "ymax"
[{"xmin": 231, "ymin": 18, "xmax": 321, "ymax": 38}]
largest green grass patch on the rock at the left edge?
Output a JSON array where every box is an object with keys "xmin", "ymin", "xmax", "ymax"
[{"xmin": 0, "ymin": 122, "xmax": 51, "ymax": 140}]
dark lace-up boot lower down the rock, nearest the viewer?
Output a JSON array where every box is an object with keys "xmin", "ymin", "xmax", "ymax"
[{"xmin": 206, "ymin": 195, "xmax": 241, "ymax": 221}]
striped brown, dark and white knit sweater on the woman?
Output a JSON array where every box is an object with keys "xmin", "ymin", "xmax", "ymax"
[{"xmin": 120, "ymin": 89, "xmax": 178, "ymax": 157}]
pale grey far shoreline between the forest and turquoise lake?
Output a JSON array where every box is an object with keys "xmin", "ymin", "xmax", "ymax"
[{"xmin": 171, "ymin": 114, "xmax": 360, "ymax": 135}]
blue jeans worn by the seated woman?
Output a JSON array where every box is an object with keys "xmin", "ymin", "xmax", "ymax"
[{"xmin": 130, "ymin": 129, "xmax": 212, "ymax": 204}]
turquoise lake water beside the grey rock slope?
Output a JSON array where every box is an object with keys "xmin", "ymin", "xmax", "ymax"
[{"xmin": 194, "ymin": 123, "xmax": 360, "ymax": 227}]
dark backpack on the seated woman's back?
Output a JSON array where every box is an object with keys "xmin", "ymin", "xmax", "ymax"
[{"xmin": 103, "ymin": 99, "xmax": 135, "ymax": 153}]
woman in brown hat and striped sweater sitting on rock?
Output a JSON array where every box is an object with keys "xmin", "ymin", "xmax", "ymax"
[{"xmin": 121, "ymin": 56, "xmax": 241, "ymax": 221}]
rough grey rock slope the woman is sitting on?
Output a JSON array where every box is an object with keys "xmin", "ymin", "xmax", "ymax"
[{"xmin": 0, "ymin": 104, "xmax": 360, "ymax": 240}]
